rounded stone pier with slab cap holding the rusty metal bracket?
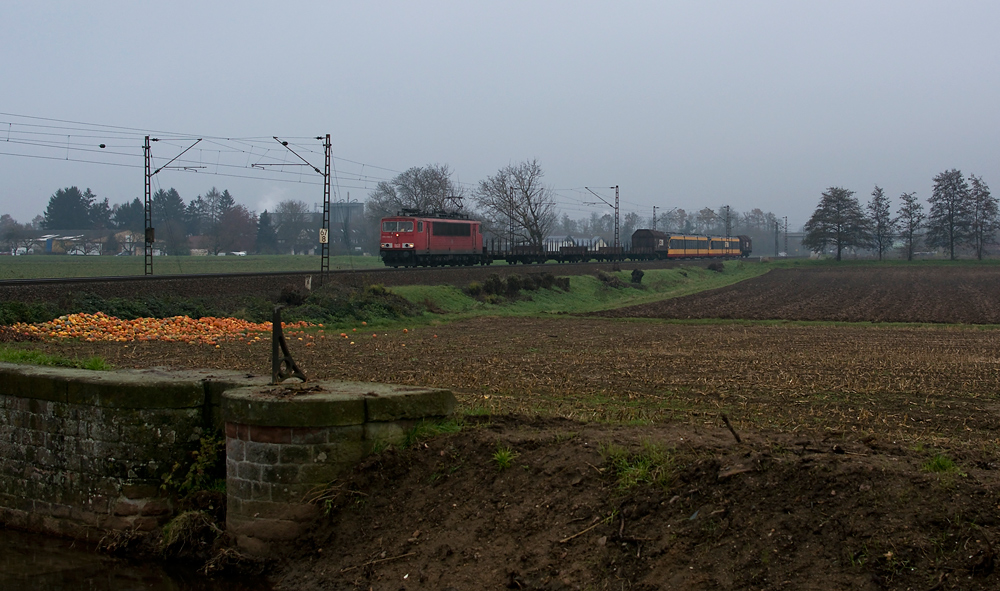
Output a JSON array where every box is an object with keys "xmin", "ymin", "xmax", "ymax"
[{"xmin": 223, "ymin": 382, "xmax": 455, "ymax": 554}]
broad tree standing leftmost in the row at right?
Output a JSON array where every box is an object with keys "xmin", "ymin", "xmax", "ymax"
[{"xmin": 802, "ymin": 187, "xmax": 869, "ymax": 261}]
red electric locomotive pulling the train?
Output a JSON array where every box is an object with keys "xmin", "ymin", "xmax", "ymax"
[{"xmin": 379, "ymin": 209, "xmax": 490, "ymax": 267}]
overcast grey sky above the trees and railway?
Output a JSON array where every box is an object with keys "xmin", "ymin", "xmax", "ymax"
[{"xmin": 0, "ymin": 0, "xmax": 1000, "ymax": 229}]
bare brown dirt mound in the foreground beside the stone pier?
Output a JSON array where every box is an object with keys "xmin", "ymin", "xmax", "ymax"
[{"xmin": 278, "ymin": 416, "xmax": 1000, "ymax": 590}]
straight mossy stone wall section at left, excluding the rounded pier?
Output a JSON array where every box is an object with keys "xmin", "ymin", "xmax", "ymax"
[{"xmin": 0, "ymin": 364, "xmax": 261, "ymax": 539}]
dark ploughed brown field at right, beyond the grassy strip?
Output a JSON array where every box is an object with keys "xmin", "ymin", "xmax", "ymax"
[{"xmin": 597, "ymin": 265, "xmax": 1000, "ymax": 324}]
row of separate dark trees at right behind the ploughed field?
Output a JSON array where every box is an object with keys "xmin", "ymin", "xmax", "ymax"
[{"xmin": 802, "ymin": 169, "xmax": 1000, "ymax": 261}]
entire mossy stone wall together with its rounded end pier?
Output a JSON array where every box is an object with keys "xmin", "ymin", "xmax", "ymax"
[{"xmin": 0, "ymin": 363, "xmax": 455, "ymax": 553}]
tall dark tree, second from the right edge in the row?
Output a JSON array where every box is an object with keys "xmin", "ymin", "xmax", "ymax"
[{"xmin": 926, "ymin": 168, "xmax": 972, "ymax": 260}]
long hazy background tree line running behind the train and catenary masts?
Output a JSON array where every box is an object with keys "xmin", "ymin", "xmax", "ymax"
[{"xmin": 0, "ymin": 159, "xmax": 779, "ymax": 255}]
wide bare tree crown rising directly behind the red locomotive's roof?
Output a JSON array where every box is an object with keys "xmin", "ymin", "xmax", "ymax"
[{"xmin": 365, "ymin": 164, "xmax": 465, "ymax": 220}]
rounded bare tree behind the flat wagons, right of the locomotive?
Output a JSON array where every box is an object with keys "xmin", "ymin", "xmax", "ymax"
[{"xmin": 474, "ymin": 160, "xmax": 556, "ymax": 248}]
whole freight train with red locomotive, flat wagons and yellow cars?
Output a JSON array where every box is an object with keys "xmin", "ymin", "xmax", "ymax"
[{"xmin": 379, "ymin": 209, "xmax": 752, "ymax": 267}]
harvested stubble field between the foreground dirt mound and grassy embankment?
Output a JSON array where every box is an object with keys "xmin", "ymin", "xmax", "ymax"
[{"xmin": 32, "ymin": 318, "xmax": 1000, "ymax": 448}]
